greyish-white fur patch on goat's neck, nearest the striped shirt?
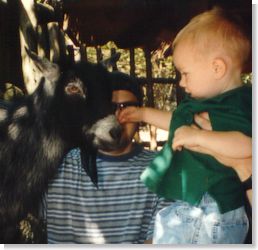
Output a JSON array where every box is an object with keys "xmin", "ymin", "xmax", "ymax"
[{"xmin": 42, "ymin": 136, "xmax": 63, "ymax": 160}]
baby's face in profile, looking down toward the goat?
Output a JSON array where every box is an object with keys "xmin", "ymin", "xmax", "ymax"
[{"xmin": 173, "ymin": 42, "xmax": 226, "ymax": 99}]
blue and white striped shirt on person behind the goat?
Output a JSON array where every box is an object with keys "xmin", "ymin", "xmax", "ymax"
[{"xmin": 46, "ymin": 145, "xmax": 170, "ymax": 244}]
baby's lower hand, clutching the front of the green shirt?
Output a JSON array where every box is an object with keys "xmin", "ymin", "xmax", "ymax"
[{"xmin": 172, "ymin": 125, "xmax": 200, "ymax": 151}]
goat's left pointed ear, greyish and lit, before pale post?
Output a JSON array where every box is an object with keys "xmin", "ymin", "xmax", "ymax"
[{"xmin": 25, "ymin": 47, "xmax": 60, "ymax": 82}]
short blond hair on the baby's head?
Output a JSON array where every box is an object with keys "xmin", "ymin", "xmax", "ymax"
[{"xmin": 172, "ymin": 7, "xmax": 251, "ymax": 69}]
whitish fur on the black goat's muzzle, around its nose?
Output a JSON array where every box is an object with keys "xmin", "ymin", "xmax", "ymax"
[{"xmin": 89, "ymin": 115, "xmax": 120, "ymax": 145}]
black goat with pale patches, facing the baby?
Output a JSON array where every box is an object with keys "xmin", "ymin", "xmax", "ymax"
[{"xmin": 0, "ymin": 52, "xmax": 121, "ymax": 243}]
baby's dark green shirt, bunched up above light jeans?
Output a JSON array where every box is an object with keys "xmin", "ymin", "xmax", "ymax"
[{"xmin": 141, "ymin": 85, "xmax": 252, "ymax": 213}]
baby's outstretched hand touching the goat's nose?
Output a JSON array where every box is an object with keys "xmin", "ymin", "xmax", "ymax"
[{"xmin": 118, "ymin": 107, "xmax": 143, "ymax": 123}]
